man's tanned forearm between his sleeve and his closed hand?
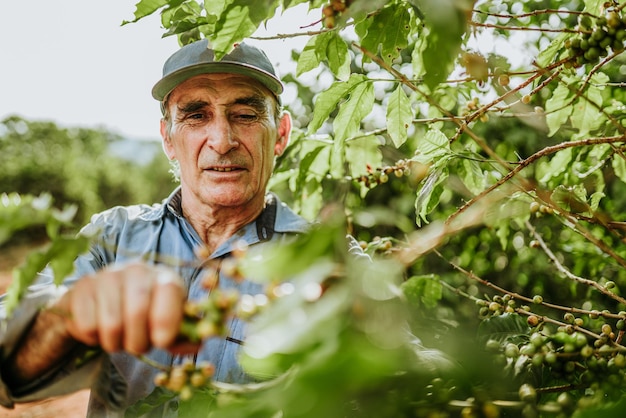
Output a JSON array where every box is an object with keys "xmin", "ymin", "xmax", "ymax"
[{"xmin": 1, "ymin": 309, "xmax": 78, "ymax": 389}]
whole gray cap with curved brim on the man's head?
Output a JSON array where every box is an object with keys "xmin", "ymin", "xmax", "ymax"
[{"xmin": 152, "ymin": 39, "xmax": 283, "ymax": 101}]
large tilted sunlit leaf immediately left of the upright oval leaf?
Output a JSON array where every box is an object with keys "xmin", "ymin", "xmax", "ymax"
[{"xmin": 333, "ymin": 80, "xmax": 374, "ymax": 142}]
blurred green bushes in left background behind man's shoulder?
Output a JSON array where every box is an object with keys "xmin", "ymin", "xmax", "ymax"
[{"xmin": 0, "ymin": 116, "xmax": 175, "ymax": 234}]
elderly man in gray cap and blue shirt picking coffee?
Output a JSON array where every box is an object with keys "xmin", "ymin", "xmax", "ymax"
[{"xmin": 0, "ymin": 40, "xmax": 308, "ymax": 416}]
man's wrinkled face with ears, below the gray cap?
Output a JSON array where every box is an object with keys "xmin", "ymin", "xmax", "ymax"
[{"xmin": 161, "ymin": 74, "xmax": 291, "ymax": 212}]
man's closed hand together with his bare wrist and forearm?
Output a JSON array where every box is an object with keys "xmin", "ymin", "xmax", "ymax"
[{"xmin": 2, "ymin": 263, "xmax": 186, "ymax": 387}]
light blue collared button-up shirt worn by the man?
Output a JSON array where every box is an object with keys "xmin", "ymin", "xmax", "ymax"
[{"xmin": 0, "ymin": 188, "xmax": 310, "ymax": 417}]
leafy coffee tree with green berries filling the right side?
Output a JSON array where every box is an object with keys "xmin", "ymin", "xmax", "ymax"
[{"xmin": 3, "ymin": 0, "xmax": 626, "ymax": 417}]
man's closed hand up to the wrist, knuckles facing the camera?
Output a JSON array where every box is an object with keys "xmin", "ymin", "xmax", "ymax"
[{"xmin": 52, "ymin": 264, "xmax": 186, "ymax": 353}]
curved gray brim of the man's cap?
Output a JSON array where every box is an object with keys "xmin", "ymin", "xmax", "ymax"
[{"xmin": 152, "ymin": 61, "xmax": 283, "ymax": 101}]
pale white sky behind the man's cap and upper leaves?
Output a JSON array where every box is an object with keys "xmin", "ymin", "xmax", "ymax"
[{"xmin": 0, "ymin": 0, "xmax": 316, "ymax": 140}]
